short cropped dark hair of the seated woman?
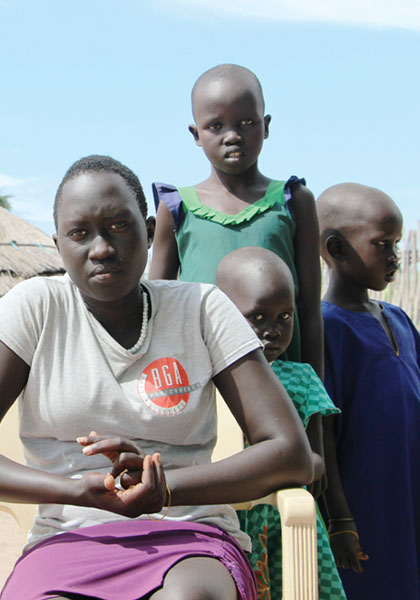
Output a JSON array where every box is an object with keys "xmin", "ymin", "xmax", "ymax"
[{"xmin": 53, "ymin": 154, "xmax": 147, "ymax": 227}]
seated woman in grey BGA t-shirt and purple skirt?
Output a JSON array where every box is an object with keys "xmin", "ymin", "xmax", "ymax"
[{"xmin": 0, "ymin": 156, "xmax": 322, "ymax": 600}]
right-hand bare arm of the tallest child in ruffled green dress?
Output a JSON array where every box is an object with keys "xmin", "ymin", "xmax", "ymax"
[{"xmin": 290, "ymin": 185, "xmax": 324, "ymax": 380}]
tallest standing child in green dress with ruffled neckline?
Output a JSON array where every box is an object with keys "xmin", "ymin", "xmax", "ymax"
[{"xmin": 149, "ymin": 64, "xmax": 323, "ymax": 376}]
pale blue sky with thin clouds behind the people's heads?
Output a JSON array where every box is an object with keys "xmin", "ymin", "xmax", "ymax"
[{"xmin": 0, "ymin": 0, "xmax": 420, "ymax": 234}]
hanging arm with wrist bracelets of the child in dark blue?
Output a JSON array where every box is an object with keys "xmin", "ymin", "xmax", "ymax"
[{"xmin": 324, "ymin": 416, "xmax": 368, "ymax": 573}]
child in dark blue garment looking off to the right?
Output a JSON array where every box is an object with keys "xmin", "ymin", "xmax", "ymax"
[{"xmin": 317, "ymin": 183, "xmax": 420, "ymax": 600}]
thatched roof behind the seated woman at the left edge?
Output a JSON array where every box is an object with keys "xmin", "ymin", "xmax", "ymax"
[{"xmin": 0, "ymin": 207, "xmax": 64, "ymax": 296}]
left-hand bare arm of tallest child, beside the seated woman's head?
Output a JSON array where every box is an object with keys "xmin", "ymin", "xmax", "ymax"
[{"xmin": 149, "ymin": 202, "xmax": 179, "ymax": 279}]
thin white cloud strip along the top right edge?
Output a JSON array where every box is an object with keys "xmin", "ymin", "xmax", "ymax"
[{"xmin": 154, "ymin": 0, "xmax": 420, "ymax": 31}]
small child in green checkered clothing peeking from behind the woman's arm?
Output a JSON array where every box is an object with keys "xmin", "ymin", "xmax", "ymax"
[{"xmin": 217, "ymin": 247, "xmax": 346, "ymax": 600}]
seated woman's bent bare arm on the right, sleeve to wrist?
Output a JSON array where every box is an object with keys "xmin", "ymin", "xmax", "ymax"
[{"xmin": 158, "ymin": 350, "xmax": 322, "ymax": 504}]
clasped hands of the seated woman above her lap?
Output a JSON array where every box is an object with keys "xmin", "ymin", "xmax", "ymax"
[{"xmin": 77, "ymin": 431, "xmax": 166, "ymax": 517}]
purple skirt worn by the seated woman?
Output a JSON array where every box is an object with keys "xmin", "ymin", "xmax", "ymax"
[{"xmin": 1, "ymin": 520, "xmax": 257, "ymax": 600}]
